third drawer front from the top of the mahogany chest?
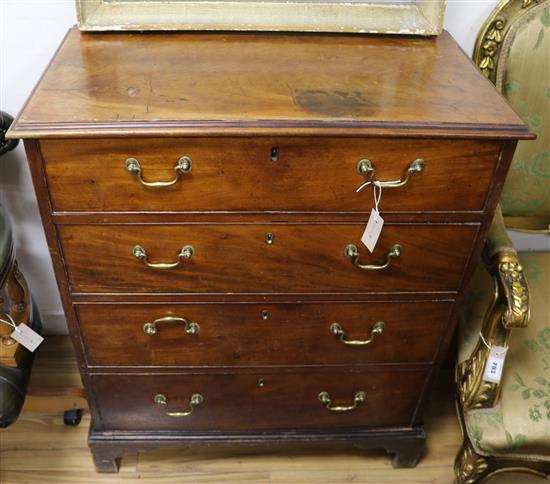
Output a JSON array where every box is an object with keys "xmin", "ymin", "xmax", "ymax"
[{"xmin": 77, "ymin": 302, "xmax": 458, "ymax": 366}]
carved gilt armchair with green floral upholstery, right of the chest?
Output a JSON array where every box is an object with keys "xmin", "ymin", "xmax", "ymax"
[{"xmin": 455, "ymin": 0, "xmax": 550, "ymax": 484}]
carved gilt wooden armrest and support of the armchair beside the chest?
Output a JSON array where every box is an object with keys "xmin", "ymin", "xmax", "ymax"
[{"xmin": 456, "ymin": 207, "xmax": 529, "ymax": 411}]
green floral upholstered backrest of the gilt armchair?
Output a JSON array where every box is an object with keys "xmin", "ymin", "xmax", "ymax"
[{"xmin": 497, "ymin": 7, "xmax": 550, "ymax": 228}]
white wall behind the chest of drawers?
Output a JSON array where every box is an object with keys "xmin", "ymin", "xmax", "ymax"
[{"xmin": 0, "ymin": 0, "xmax": 536, "ymax": 333}]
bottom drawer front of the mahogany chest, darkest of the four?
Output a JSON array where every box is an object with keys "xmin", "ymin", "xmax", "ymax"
[{"xmin": 91, "ymin": 370, "xmax": 427, "ymax": 431}]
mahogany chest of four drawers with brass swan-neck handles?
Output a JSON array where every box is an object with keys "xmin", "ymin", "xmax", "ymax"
[{"xmin": 9, "ymin": 29, "xmax": 531, "ymax": 472}]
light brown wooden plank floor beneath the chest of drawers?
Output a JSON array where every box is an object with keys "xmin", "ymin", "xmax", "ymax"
[{"xmin": 0, "ymin": 336, "xmax": 542, "ymax": 484}]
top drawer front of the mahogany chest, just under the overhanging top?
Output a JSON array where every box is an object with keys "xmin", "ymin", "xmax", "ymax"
[{"xmin": 41, "ymin": 137, "xmax": 500, "ymax": 212}]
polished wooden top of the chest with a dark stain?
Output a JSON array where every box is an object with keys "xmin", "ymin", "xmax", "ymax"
[{"xmin": 10, "ymin": 28, "xmax": 530, "ymax": 138}]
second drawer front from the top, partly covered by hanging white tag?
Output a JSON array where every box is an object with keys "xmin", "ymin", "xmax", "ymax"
[{"xmin": 59, "ymin": 224, "xmax": 477, "ymax": 293}]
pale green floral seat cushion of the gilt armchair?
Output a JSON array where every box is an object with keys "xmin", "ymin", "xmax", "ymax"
[{"xmin": 459, "ymin": 252, "xmax": 550, "ymax": 461}]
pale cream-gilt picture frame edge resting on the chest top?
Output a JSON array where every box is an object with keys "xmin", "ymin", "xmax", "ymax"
[{"xmin": 76, "ymin": 0, "xmax": 445, "ymax": 36}]
